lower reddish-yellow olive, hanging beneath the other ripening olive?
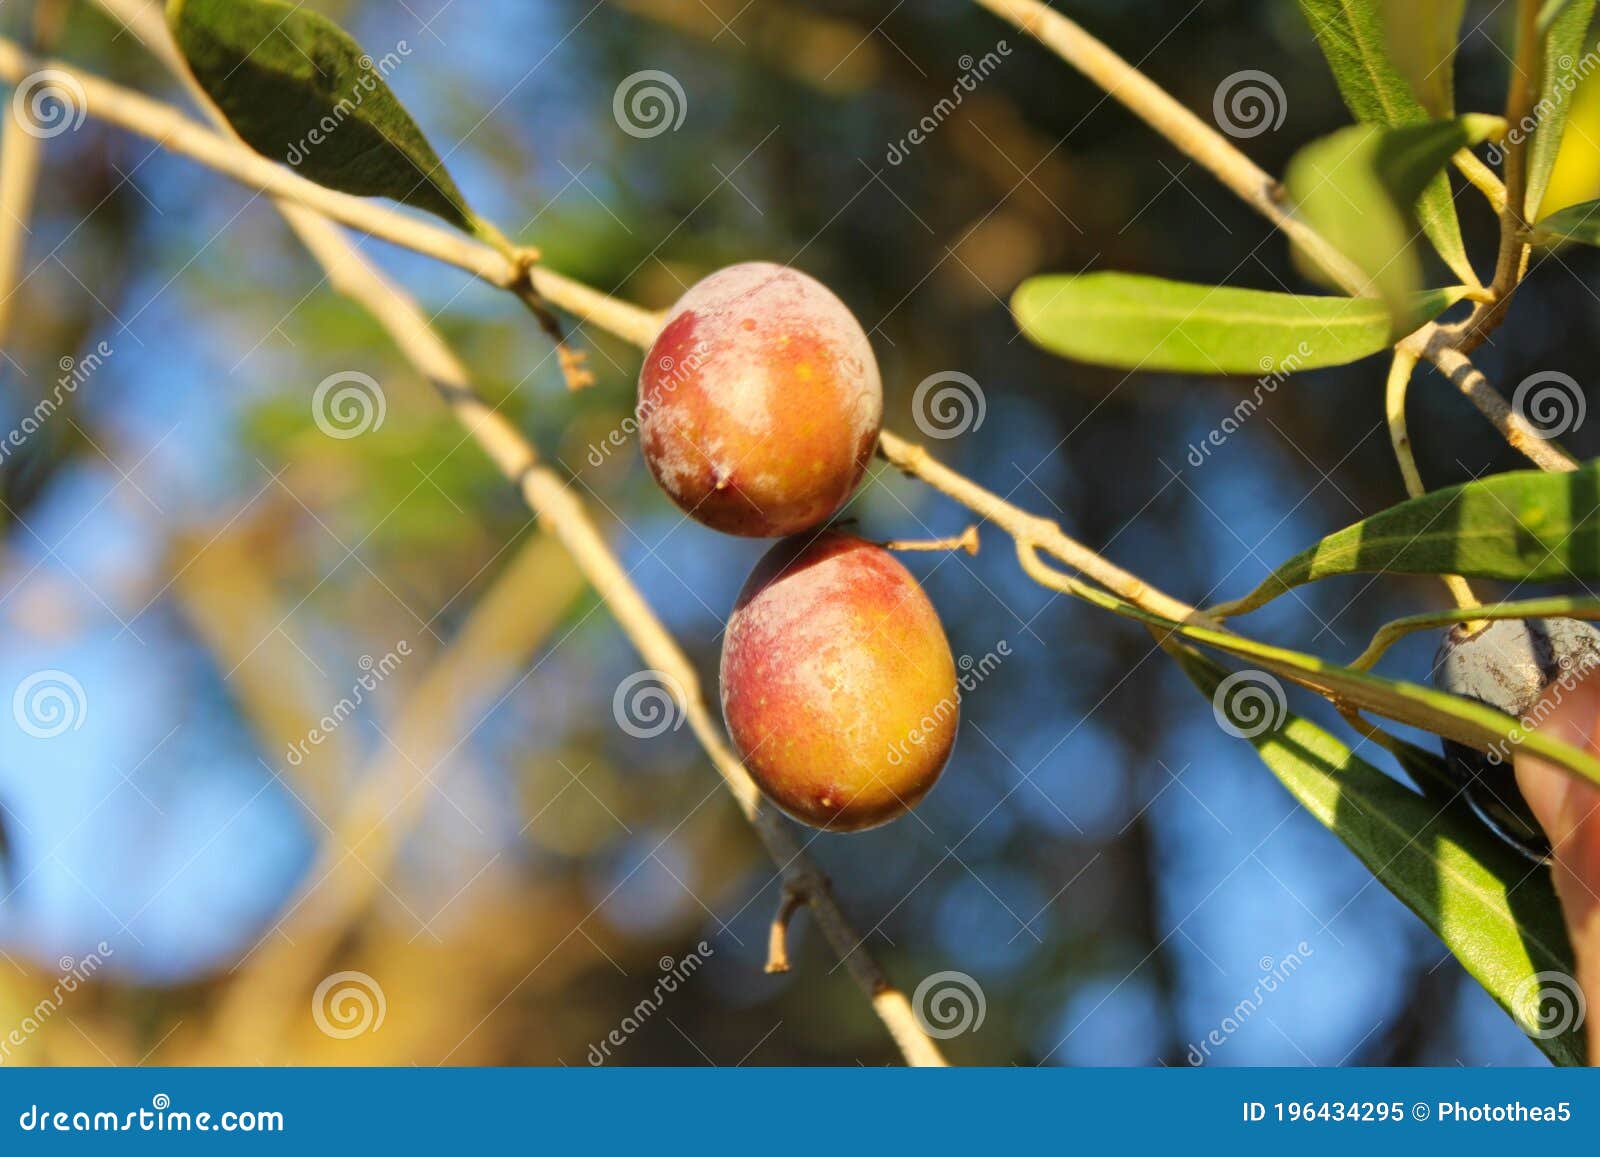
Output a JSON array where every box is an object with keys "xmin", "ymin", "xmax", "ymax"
[{"xmin": 722, "ymin": 531, "xmax": 960, "ymax": 832}]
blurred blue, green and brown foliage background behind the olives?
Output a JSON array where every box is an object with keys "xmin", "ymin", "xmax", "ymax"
[{"xmin": 0, "ymin": 0, "xmax": 1600, "ymax": 1064}]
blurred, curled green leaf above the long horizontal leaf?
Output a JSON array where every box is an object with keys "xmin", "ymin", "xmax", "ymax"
[{"xmin": 1285, "ymin": 117, "xmax": 1490, "ymax": 302}]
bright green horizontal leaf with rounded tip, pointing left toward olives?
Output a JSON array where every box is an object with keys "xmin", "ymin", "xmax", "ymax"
[{"xmin": 1011, "ymin": 274, "xmax": 1461, "ymax": 374}]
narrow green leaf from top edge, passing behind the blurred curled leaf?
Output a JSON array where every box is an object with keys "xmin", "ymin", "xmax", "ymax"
[{"xmin": 1299, "ymin": 0, "xmax": 1472, "ymax": 283}]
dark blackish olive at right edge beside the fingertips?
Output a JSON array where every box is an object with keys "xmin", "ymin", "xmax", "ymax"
[{"xmin": 1434, "ymin": 619, "xmax": 1600, "ymax": 861}]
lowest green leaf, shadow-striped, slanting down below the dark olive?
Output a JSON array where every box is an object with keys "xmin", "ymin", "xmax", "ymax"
[{"xmin": 1170, "ymin": 645, "xmax": 1584, "ymax": 1064}]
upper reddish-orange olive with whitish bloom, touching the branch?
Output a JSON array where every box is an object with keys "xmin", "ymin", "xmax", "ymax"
[{"xmin": 638, "ymin": 262, "xmax": 883, "ymax": 538}]
